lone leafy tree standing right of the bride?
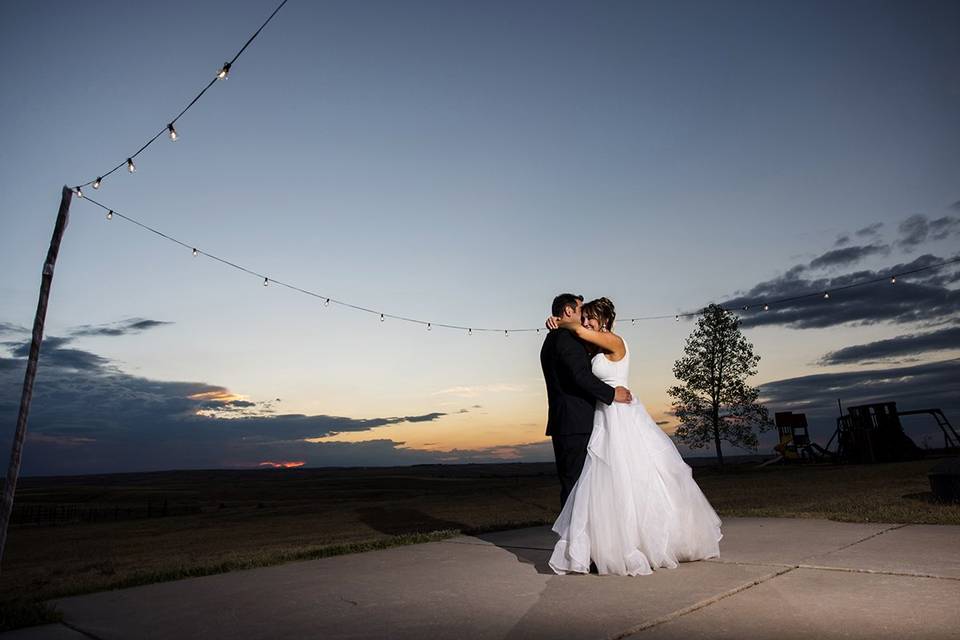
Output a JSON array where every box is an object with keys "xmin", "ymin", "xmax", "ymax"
[{"xmin": 667, "ymin": 304, "xmax": 773, "ymax": 467}]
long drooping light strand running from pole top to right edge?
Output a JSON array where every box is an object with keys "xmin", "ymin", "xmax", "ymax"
[{"xmin": 77, "ymin": 196, "xmax": 960, "ymax": 336}]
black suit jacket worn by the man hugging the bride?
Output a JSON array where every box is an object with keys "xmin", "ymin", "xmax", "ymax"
[{"xmin": 540, "ymin": 329, "xmax": 614, "ymax": 436}]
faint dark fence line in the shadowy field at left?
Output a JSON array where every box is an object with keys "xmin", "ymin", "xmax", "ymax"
[{"xmin": 10, "ymin": 500, "xmax": 200, "ymax": 525}]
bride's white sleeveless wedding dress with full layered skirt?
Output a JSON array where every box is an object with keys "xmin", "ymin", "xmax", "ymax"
[{"xmin": 550, "ymin": 342, "xmax": 723, "ymax": 576}]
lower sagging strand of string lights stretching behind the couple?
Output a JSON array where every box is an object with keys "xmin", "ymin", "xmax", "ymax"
[{"xmin": 71, "ymin": 197, "xmax": 960, "ymax": 336}]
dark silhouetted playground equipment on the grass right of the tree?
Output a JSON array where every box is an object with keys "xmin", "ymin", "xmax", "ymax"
[{"xmin": 761, "ymin": 402, "xmax": 960, "ymax": 466}]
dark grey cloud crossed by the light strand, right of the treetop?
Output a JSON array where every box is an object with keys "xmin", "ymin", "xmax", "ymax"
[{"xmin": 722, "ymin": 254, "xmax": 960, "ymax": 329}]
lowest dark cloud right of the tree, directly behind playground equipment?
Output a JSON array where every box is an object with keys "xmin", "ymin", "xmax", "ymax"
[{"xmin": 759, "ymin": 358, "xmax": 960, "ymax": 447}]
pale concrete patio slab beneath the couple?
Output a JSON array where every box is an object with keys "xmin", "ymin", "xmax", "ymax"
[{"xmin": 0, "ymin": 518, "xmax": 960, "ymax": 640}]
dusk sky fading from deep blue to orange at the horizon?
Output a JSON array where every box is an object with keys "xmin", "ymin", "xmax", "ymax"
[{"xmin": 0, "ymin": 0, "xmax": 960, "ymax": 475}]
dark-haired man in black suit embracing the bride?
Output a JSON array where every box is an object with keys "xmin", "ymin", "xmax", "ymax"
[{"xmin": 540, "ymin": 293, "xmax": 633, "ymax": 508}]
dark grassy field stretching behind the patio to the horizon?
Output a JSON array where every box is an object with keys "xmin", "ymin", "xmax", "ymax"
[{"xmin": 0, "ymin": 460, "xmax": 960, "ymax": 629}]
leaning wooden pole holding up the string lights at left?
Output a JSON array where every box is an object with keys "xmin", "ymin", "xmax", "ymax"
[{"xmin": 0, "ymin": 186, "xmax": 73, "ymax": 564}]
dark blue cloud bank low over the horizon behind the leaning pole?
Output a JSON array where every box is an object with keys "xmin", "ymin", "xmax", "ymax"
[{"xmin": 0, "ymin": 337, "xmax": 464, "ymax": 475}]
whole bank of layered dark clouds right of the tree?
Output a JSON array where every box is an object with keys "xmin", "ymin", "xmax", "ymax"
[{"xmin": 722, "ymin": 207, "xmax": 960, "ymax": 449}]
